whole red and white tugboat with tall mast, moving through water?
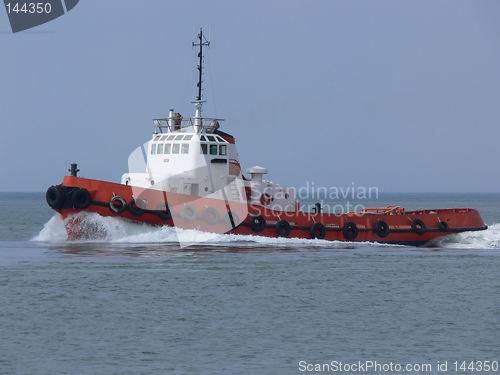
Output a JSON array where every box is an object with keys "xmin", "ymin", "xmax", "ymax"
[{"xmin": 46, "ymin": 29, "xmax": 487, "ymax": 246}]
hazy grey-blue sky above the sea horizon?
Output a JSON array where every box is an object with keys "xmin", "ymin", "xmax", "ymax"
[{"xmin": 0, "ymin": 0, "xmax": 500, "ymax": 192}]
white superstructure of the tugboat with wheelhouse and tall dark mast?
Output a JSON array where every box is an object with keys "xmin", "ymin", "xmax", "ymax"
[{"xmin": 121, "ymin": 27, "xmax": 297, "ymax": 212}]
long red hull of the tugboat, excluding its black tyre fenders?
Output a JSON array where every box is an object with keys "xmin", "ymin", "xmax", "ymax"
[{"xmin": 51, "ymin": 176, "xmax": 487, "ymax": 245}]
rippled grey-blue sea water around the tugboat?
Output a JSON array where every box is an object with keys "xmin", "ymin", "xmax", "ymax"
[{"xmin": 0, "ymin": 193, "xmax": 500, "ymax": 375}]
